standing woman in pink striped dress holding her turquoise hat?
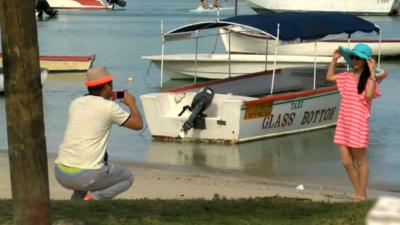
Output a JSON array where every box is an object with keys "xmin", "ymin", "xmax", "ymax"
[{"xmin": 326, "ymin": 43, "xmax": 386, "ymax": 202}]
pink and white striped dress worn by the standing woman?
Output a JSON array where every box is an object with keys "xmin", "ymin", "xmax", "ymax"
[{"xmin": 333, "ymin": 72, "xmax": 381, "ymax": 149}]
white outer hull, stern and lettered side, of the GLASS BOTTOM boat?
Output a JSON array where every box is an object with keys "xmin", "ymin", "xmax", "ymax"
[{"xmin": 140, "ymin": 89, "xmax": 339, "ymax": 143}]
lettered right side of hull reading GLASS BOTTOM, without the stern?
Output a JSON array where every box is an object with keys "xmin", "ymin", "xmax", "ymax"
[{"xmin": 238, "ymin": 90, "xmax": 340, "ymax": 142}]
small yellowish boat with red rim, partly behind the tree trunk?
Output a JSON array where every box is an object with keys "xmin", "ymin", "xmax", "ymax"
[{"xmin": 0, "ymin": 53, "xmax": 96, "ymax": 73}]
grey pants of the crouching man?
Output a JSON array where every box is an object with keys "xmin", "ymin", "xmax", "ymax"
[{"xmin": 54, "ymin": 162, "xmax": 133, "ymax": 200}]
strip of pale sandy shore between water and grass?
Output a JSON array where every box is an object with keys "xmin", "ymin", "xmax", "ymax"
[{"xmin": 0, "ymin": 150, "xmax": 399, "ymax": 202}]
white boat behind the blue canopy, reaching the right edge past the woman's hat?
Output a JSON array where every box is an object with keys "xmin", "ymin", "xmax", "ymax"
[{"xmin": 220, "ymin": 27, "xmax": 400, "ymax": 56}]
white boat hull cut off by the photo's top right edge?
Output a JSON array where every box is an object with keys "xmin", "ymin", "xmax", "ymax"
[{"xmin": 244, "ymin": 0, "xmax": 400, "ymax": 15}]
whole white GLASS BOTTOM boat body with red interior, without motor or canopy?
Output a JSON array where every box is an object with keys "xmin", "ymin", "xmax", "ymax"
[{"xmin": 140, "ymin": 68, "xmax": 339, "ymax": 143}]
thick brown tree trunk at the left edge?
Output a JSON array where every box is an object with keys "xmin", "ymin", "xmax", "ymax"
[{"xmin": 0, "ymin": 0, "xmax": 51, "ymax": 225}]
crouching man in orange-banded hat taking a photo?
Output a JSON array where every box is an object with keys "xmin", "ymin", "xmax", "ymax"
[{"xmin": 54, "ymin": 67, "xmax": 143, "ymax": 200}]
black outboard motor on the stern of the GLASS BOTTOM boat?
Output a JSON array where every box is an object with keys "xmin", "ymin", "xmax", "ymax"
[{"xmin": 178, "ymin": 87, "xmax": 214, "ymax": 133}]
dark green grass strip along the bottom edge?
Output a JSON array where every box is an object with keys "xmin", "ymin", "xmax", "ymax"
[{"xmin": 0, "ymin": 197, "xmax": 373, "ymax": 225}]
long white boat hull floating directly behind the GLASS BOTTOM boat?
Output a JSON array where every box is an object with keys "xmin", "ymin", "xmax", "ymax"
[{"xmin": 142, "ymin": 54, "xmax": 344, "ymax": 79}]
